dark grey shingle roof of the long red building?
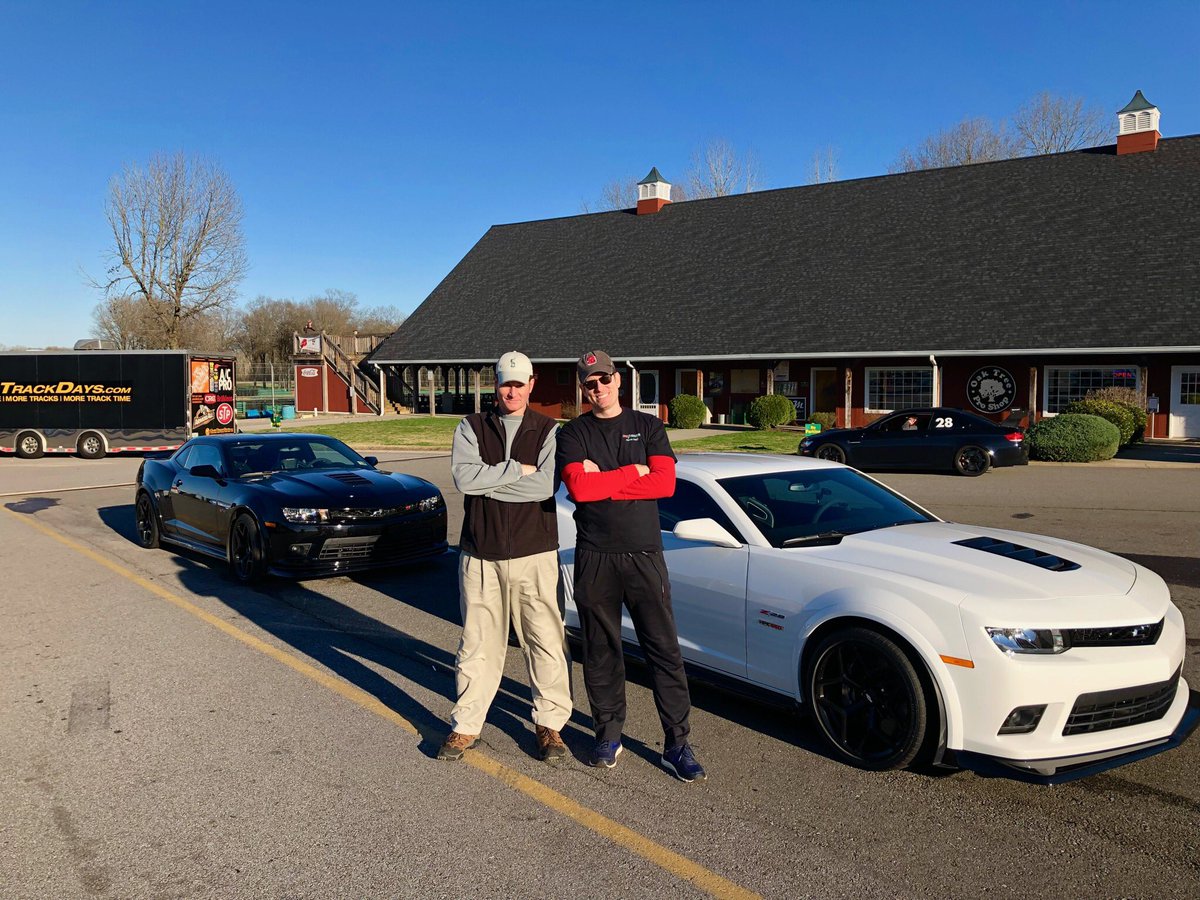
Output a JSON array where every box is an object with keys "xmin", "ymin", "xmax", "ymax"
[{"xmin": 372, "ymin": 136, "xmax": 1200, "ymax": 362}]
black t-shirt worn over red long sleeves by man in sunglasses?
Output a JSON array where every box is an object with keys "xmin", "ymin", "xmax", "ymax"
[{"xmin": 557, "ymin": 409, "xmax": 676, "ymax": 553}]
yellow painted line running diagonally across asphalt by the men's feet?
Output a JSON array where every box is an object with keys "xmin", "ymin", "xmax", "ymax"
[{"xmin": 6, "ymin": 510, "xmax": 758, "ymax": 899}]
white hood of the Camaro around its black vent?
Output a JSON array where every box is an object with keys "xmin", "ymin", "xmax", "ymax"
[{"xmin": 808, "ymin": 522, "xmax": 1139, "ymax": 602}]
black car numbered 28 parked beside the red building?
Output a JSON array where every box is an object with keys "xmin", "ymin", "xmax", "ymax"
[{"xmin": 800, "ymin": 407, "xmax": 1030, "ymax": 475}]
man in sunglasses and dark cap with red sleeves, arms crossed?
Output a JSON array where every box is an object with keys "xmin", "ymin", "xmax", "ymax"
[{"xmin": 558, "ymin": 350, "xmax": 704, "ymax": 781}]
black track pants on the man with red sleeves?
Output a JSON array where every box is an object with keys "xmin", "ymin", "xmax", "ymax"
[{"xmin": 575, "ymin": 550, "xmax": 691, "ymax": 750}]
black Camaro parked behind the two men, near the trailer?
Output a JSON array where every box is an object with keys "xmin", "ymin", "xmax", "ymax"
[{"xmin": 136, "ymin": 433, "xmax": 446, "ymax": 582}]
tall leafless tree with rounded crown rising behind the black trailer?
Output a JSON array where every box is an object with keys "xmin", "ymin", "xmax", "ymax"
[{"xmin": 94, "ymin": 154, "xmax": 246, "ymax": 349}]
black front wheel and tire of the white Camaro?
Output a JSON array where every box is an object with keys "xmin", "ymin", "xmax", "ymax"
[{"xmin": 804, "ymin": 628, "xmax": 936, "ymax": 772}]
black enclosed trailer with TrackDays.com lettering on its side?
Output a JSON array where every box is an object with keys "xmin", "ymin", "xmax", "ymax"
[{"xmin": 0, "ymin": 350, "xmax": 238, "ymax": 460}]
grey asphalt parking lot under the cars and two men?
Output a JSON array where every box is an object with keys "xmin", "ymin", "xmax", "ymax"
[{"xmin": 0, "ymin": 454, "xmax": 1200, "ymax": 898}]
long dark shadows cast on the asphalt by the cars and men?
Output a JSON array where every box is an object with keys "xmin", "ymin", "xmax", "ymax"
[{"xmin": 98, "ymin": 504, "xmax": 854, "ymax": 766}]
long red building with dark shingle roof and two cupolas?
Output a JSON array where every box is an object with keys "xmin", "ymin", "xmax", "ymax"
[{"xmin": 370, "ymin": 92, "xmax": 1200, "ymax": 437}]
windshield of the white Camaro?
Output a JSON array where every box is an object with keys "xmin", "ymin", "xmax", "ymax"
[{"xmin": 718, "ymin": 468, "xmax": 937, "ymax": 547}]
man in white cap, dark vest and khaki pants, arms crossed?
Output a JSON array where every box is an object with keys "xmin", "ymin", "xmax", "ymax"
[{"xmin": 438, "ymin": 350, "xmax": 572, "ymax": 763}]
